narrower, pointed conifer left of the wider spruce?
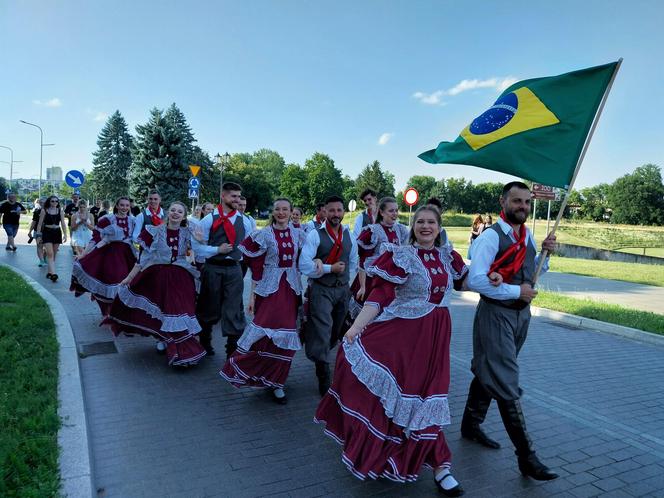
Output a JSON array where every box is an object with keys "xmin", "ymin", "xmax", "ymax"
[{"xmin": 91, "ymin": 111, "xmax": 133, "ymax": 200}]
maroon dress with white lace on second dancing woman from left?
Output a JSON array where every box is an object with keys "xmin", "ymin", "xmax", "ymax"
[{"xmin": 103, "ymin": 223, "xmax": 205, "ymax": 366}]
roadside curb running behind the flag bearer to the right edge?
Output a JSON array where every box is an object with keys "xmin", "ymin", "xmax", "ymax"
[{"xmin": 457, "ymin": 292, "xmax": 664, "ymax": 346}]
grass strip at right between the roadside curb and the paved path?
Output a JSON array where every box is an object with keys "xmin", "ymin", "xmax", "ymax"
[{"xmin": 533, "ymin": 291, "xmax": 664, "ymax": 335}]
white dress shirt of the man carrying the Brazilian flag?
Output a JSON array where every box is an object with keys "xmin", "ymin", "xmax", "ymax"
[{"xmin": 468, "ymin": 218, "xmax": 549, "ymax": 300}]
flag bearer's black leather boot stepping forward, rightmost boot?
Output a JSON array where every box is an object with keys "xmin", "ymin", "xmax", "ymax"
[{"xmin": 497, "ymin": 399, "xmax": 558, "ymax": 481}]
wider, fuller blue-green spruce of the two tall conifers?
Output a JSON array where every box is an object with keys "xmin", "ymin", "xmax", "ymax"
[{"xmin": 129, "ymin": 104, "xmax": 195, "ymax": 206}]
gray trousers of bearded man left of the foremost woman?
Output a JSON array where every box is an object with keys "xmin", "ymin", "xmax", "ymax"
[{"xmin": 304, "ymin": 280, "xmax": 350, "ymax": 363}]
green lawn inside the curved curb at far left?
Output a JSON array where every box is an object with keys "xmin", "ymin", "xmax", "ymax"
[{"xmin": 0, "ymin": 267, "xmax": 60, "ymax": 498}]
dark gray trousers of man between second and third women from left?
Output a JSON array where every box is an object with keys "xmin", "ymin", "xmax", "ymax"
[{"xmin": 196, "ymin": 263, "xmax": 246, "ymax": 336}]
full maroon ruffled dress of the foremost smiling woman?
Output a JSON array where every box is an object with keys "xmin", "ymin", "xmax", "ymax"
[{"xmin": 314, "ymin": 244, "xmax": 467, "ymax": 482}]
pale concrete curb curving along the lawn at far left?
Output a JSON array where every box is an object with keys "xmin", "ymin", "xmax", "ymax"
[{"xmin": 0, "ymin": 263, "xmax": 96, "ymax": 498}]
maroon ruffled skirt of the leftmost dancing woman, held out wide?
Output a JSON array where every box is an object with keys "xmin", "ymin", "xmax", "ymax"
[{"xmin": 69, "ymin": 242, "xmax": 136, "ymax": 316}]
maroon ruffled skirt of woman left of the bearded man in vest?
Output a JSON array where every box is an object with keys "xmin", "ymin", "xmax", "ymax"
[{"xmin": 219, "ymin": 274, "xmax": 302, "ymax": 388}]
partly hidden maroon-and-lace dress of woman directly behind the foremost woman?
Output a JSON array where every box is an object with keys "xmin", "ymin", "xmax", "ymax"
[{"xmin": 347, "ymin": 221, "xmax": 408, "ymax": 320}]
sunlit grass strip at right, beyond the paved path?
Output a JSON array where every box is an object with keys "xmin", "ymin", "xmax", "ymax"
[{"xmin": 549, "ymin": 256, "xmax": 664, "ymax": 287}]
